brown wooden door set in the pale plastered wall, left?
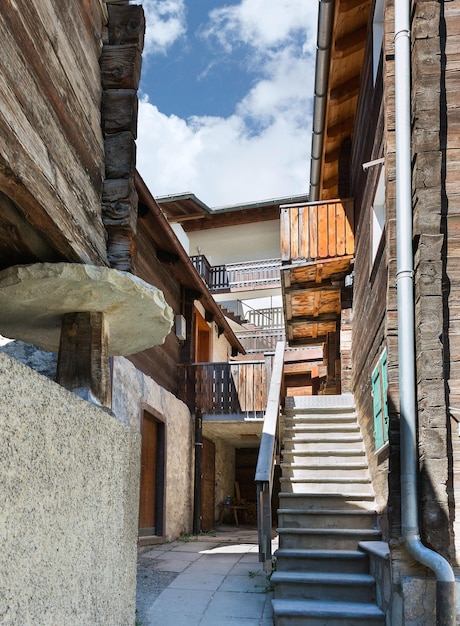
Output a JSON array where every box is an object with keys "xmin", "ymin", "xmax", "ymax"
[{"xmin": 139, "ymin": 412, "xmax": 164, "ymax": 536}]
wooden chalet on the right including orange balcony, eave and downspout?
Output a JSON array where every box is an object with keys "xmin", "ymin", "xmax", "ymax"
[{"xmin": 274, "ymin": 0, "xmax": 460, "ymax": 625}]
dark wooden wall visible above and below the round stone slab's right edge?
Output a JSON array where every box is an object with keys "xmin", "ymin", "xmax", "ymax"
[{"xmin": 128, "ymin": 219, "xmax": 181, "ymax": 395}]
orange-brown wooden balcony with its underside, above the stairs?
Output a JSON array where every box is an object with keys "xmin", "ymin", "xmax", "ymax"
[{"xmin": 281, "ymin": 199, "xmax": 354, "ymax": 356}]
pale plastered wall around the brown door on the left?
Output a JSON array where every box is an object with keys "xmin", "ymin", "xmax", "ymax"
[{"xmin": 112, "ymin": 357, "xmax": 194, "ymax": 541}]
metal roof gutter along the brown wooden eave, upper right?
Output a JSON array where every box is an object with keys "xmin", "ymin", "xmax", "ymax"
[{"xmin": 308, "ymin": 0, "xmax": 335, "ymax": 202}]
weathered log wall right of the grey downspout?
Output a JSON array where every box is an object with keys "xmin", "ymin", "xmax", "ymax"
[{"xmin": 412, "ymin": 2, "xmax": 460, "ymax": 562}]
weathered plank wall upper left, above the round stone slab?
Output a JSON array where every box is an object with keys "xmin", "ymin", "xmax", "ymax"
[{"xmin": 0, "ymin": 0, "xmax": 107, "ymax": 264}]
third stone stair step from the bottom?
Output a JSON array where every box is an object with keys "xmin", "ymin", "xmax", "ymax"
[{"xmin": 275, "ymin": 548, "xmax": 369, "ymax": 574}]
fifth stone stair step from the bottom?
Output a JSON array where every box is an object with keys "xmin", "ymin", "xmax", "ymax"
[{"xmin": 278, "ymin": 509, "xmax": 376, "ymax": 529}]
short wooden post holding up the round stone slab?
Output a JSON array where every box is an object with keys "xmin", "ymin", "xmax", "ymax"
[{"xmin": 56, "ymin": 313, "xmax": 112, "ymax": 407}]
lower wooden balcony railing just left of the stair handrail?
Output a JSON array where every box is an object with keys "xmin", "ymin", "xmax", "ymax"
[{"xmin": 178, "ymin": 360, "xmax": 271, "ymax": 418}]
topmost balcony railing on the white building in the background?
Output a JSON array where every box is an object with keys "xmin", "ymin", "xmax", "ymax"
[{"xmin": 190, "ymin": 254, "xmax": 281, "ymax": 293}]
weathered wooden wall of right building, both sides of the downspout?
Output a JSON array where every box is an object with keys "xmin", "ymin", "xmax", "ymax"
[{"xmin": 351, "ymin": 0, "xmax": 460, "ymax": 580}]
